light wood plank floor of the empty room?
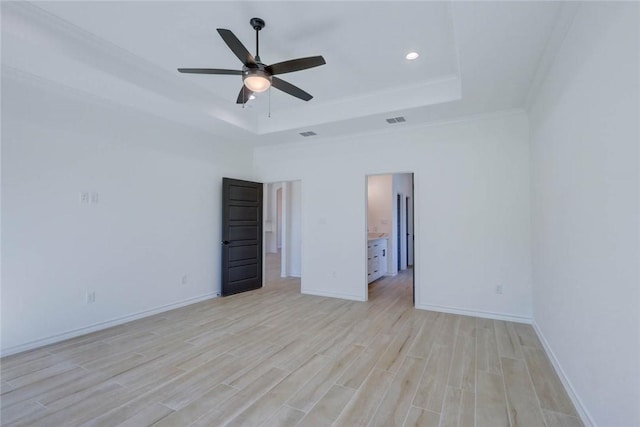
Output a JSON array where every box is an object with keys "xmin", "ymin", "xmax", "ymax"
[{"xmin": 1, "ymin": 254, "xmax": 582, "ymax": 427}]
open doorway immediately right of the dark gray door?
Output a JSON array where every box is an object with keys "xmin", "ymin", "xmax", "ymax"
[{"xmin": 263, "ymin": 181, "xmax": 302, "ymax": 286}]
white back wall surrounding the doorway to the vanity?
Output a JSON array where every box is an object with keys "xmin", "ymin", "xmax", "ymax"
[{"xmin": 254, "ymin": 113, "xmax": 531, "ymax": 319}]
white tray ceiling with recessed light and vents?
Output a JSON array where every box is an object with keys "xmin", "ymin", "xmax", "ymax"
[{"xmin": 2, "ymin": 1, "xmax": 570, "ymax": 145}]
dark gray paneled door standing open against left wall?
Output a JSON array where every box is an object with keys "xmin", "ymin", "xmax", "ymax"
[{"xmin": 222, "ymin": 178, "xmax": 262, "ymax": 296}]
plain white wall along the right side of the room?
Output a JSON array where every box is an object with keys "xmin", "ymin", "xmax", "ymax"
[{"xmin": 531, "ymin": 2, "xmax": 640, "ymax": 427}]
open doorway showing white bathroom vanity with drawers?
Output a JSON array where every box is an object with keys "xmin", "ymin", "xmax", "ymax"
[{"xmin": 365, "ymin": 173, "xmax": 415, "ymax": 305}]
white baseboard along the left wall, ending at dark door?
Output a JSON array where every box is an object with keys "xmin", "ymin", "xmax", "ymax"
[{"xmin": 0, "ymin": 293, "xmax": 218, "ymax": 357}]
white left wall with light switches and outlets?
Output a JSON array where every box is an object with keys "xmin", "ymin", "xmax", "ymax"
[{"xmin": 1, "ymin": 72, "xmax": 251, "ymax": 354}]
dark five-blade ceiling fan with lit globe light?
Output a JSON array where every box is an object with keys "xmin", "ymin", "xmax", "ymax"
[{"xmin": 178, "ymin": 18, "xmax": 326, "ymax": 104}]
